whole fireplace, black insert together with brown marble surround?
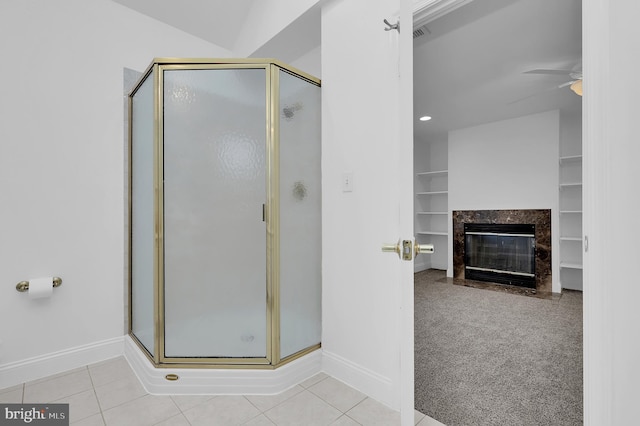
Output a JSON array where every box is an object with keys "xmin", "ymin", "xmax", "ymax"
[{"xmin": 451, "ymin": 209, "xmax": 552, "ymax": 295}]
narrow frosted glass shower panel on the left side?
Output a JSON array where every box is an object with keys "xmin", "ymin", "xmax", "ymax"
[{"xmin": 130, "ymin": 76, "xmax": 155, "ymax": 356}]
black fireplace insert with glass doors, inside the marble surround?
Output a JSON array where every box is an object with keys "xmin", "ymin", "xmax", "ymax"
[{"xmin": 464, "ymin": 223, "xmax": 536, "ymax": 288}]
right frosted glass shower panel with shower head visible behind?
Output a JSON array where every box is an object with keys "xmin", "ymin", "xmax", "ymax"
[{"xmin": 279, "ymin": 71, "xmax": 321, "ymax": 358}]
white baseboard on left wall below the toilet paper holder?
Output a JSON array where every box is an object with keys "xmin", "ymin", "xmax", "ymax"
[{"xmin": 0, "ymin": 336, "xmax": 124, "ymax": 389}]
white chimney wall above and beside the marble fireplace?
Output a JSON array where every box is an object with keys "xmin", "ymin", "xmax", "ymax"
[{"xmin": 449, "ymin": 110, "xmax": 560, "ymax": 292}]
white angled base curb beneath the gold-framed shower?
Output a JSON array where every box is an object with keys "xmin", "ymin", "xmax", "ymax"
[{"xmin": 124, "ymin": 336, "xmax": 322, "ymax": 395}]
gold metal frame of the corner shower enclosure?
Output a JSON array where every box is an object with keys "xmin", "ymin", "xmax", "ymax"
[{"xmin": 128, "ymin": 58, "xmax": 321, "ymax": 369}]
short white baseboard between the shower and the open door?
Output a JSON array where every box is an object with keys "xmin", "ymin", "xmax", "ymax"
[{"xmin": 322, "ymin": 351, "xmax": 400, "ymax": 411}]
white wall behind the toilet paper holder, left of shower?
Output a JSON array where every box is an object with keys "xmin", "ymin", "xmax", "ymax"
[{"xmin": 0, "ymin": 0, "xmax": 230, "ymax": 387}]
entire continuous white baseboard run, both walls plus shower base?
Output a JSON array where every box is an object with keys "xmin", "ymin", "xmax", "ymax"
[{"xmin": 0, "ymin": 336, "xmax": 399, "ymax": 410}]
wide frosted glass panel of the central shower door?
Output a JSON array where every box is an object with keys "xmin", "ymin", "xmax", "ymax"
[{"xmin": 163, "ymin": 68, "xmax": 267, "ymax": 358}]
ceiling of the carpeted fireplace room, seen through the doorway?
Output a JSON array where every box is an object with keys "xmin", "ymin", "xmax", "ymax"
[{"xmin": 414, "ymin": 0, "xmax": 582, "ymax": 142}]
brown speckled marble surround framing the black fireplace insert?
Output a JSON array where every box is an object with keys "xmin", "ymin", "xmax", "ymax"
[{"xmin": 452, "ymin": 210, "xmax": 551, "ymax": 294}]
